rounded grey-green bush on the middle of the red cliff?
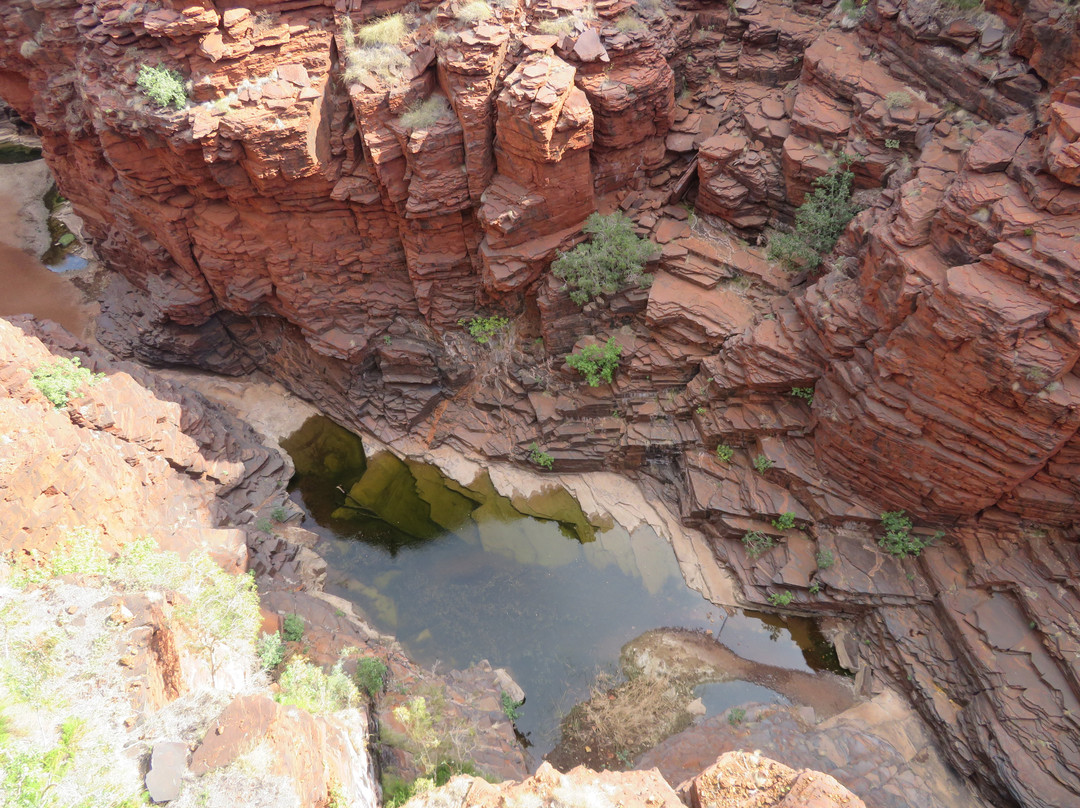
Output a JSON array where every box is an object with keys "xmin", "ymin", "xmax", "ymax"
[{"xmin": 551, "ymin": 213, "xmax": 658, "ymax": 306}]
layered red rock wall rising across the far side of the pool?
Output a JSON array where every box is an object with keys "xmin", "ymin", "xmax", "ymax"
[{"xmin": 0, "ymin": 0, "xmax": 1080, "ymax": 806}]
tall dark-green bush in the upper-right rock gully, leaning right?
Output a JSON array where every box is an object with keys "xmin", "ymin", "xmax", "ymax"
[{"xmin": 769, "ymin": 157, "xmax": 856, "ymax": 270}]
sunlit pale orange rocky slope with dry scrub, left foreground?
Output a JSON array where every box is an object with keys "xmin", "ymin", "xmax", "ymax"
[{"xmin": 0, "ymin": 317, "xmax": 378, "ymax": 806}]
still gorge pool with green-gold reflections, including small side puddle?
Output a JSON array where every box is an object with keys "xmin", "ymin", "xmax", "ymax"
[{"xmin": 283, "ymin": 417, "xmax": 842, "ymax": 754}]
